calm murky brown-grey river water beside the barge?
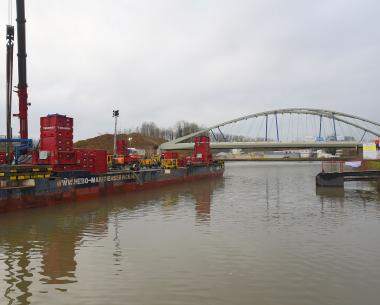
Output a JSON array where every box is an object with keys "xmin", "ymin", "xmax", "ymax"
[{"xmin": 0, "ymin": 163, "xmax": 380, "ymax": 305}]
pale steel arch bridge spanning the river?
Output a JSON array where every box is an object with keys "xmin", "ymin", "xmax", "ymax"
[{"xmin": 160, "ymin": 108, "xmax": 380, "ymax": 150}]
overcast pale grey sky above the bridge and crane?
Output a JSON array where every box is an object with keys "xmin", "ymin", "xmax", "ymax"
[{"xmin": 0, "ymin": 0, "xmax": 380, "ymax": 139}]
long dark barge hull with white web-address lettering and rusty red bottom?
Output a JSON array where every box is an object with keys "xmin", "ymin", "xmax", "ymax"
[{"xmin": 0, "ymin": 165, "xmax": 224, "ymax": 213}]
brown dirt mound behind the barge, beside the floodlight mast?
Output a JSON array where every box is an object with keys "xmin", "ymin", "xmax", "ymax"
[{"xmin": 74, "ymin": 132, "xmax": 166, "ymax": 155}]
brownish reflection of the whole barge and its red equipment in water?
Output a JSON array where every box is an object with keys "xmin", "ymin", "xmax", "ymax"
[{"xmin": 0, "ymin": 179, "xmax": 223, "ymax": 304}]
